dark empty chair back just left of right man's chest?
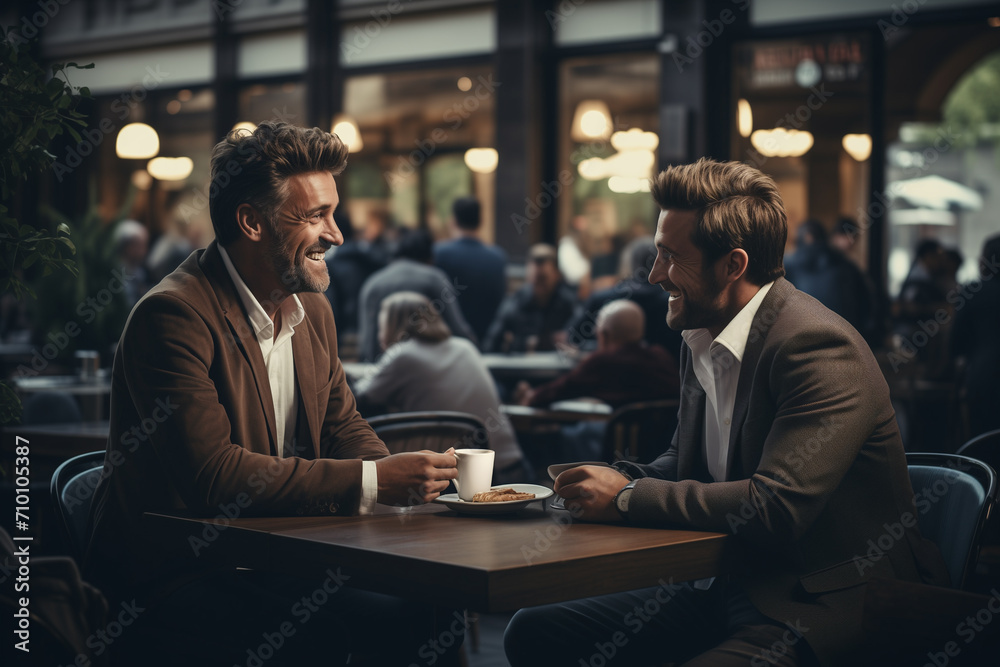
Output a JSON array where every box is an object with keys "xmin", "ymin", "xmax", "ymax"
[{"xmin": 604, "ymin": 399, "xmax": 680, "ymax": 463}]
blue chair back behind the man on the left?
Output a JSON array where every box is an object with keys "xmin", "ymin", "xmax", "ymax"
[{"xmin": 49, "ymin": 451, "xmax": 104, "ymax": 563}]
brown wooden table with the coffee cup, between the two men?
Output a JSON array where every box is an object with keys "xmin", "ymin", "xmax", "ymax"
[{"xmin": 145, "ymin": 501, "xmax": 728, "ymax": 612}]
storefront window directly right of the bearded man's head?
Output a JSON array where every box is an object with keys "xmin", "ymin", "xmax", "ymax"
[{"xmin": 344, "ymin": 66, "xmax": 503, "ymax": 240}]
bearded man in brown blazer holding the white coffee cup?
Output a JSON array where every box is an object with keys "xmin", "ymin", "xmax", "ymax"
[{"xmin": 86, "ymin": 123, "xmax": 457, "ymax": 666}]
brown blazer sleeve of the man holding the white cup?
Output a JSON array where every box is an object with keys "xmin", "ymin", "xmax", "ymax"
[{"xmin": 112, "ymin": 294, "xmax": 382, "ymax": 516}]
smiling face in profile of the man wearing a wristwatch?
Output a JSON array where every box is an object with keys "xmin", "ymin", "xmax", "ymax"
[{"xmin": 649, "ymin": 210, "xmax": 731, "ymax": 337}]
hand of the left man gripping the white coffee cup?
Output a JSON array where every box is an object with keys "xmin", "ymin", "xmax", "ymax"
[{"xmin": 375, "ymin": 448, "xmax": 458, "ymax": 505}]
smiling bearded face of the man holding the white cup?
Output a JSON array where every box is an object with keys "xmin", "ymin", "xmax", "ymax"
[{"xmin": 264, "ymin": 171, "xmax": 344, "ymax": 294}]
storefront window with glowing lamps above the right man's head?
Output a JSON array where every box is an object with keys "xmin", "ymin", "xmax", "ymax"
[{"xmin": 731, "ymin": 34, "xmax": 872, "ymax": 266}]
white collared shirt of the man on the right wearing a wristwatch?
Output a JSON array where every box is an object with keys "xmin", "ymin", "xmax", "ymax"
[{"xmin": 681, "ymin": 282, "xmax": 774, "ymax": 482}]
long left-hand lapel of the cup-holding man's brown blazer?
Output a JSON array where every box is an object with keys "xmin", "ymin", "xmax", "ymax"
[{"xmin": 201, "ymin": 241, "xmax": 278, "ymax": 456}]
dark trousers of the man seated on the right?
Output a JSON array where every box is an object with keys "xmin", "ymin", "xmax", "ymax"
[{"xmin": 504, "ymin": 580, "xmax": 815, "ymax": 667}]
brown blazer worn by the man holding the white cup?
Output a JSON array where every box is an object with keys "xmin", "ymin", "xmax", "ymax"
[{"xmin": 85, "ymin": 243, "xmax": 388, "ymax": 598}]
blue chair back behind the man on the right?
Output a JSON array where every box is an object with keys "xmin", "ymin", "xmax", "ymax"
[{"xmin": 906, "ymin": 453, "xmax": 997, "ymax": 588}]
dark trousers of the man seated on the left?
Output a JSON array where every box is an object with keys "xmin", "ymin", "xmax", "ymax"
[{"xmin": 109, "ymin": 568, "xmax": 466, "ymax": 667}]
